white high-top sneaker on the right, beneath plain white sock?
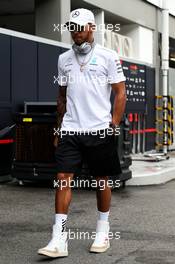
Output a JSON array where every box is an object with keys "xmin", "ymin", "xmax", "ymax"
[{"xmin": 89, "ymin": 220, "xmax": 110, "ymax": 253}]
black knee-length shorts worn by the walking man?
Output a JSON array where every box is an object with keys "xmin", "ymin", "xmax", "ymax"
[{"xmin": 55, "ymin": 129, "xmax": 121, "ymax": 176}]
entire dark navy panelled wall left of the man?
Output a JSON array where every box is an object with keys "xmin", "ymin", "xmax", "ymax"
[{"xmin": 0, "ymin": 34, "xmax": 67, "ymax": 128}]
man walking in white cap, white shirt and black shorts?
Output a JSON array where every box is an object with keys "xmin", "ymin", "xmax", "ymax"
[{"xmin": 38, "ymin": 8, "xmax": 126, "ymax": 257}]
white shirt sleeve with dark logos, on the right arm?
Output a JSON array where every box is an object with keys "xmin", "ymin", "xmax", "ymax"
[{"xmin": 108, "ymin": 51, "xmax": 126, "ymax": 84}]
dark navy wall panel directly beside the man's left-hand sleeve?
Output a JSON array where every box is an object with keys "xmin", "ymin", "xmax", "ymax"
[{"xmin": 38, "ymin": 43, "xmax": 61, "ymax": 102}]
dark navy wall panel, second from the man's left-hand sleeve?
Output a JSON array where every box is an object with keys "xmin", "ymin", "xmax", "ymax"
[{"xmin": 11, "ymin": 37, "xmax": 37, "ymax": 111}]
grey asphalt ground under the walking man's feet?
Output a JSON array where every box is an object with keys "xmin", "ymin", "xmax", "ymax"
[{"xmin": 0, "ymin": 178, "xmax": 175, "ymax": 264}]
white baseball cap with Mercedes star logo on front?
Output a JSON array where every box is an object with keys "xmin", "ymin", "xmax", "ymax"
[{"xmin": 65, "ymin": 8, "xmax": 95, "ymax": 27}]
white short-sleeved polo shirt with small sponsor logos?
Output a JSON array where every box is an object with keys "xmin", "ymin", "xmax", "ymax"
[{"xmin": 58, "ymin": 44, "xmax": 126, "ymax": 131}]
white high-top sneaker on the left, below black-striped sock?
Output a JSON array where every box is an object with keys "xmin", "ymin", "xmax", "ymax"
[{"xmin": 38, "ymin": 225, "xmax": 68, "ymax": 258}]
